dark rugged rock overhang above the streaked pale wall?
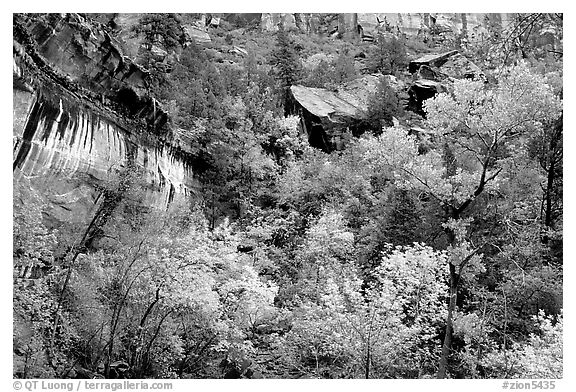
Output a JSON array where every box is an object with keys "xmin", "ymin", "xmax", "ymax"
[{"xmin": 15, "ymin": 14, "xmax": 167, "ymax": 129}]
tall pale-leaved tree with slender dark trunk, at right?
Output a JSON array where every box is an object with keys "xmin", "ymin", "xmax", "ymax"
[{"xmin": 362, "ymin": 64, "xmax": 561, "ymax": 378}]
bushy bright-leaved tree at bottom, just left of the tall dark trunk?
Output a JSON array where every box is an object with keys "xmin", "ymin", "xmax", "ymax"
[{"xmin": 287, "ymin": 241, "xmax": 446, "ymax": 378}]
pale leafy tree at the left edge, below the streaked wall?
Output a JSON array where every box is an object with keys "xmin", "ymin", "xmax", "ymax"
[{"xmin": 13, "ymin": 184, "xmax": 59, "ymax": 378}]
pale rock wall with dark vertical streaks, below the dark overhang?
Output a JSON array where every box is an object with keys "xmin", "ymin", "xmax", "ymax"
[{"xmin": 13, "ymin": 84, "xmax": 198, "ymax": 225}]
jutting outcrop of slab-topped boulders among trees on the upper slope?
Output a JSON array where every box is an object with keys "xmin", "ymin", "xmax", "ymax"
[{"xmin": 290, "ymin": 50, "xmax": 486, "ymax": 151}]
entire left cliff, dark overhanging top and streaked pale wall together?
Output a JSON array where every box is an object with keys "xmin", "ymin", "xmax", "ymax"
[{"xmin": 13, "ymin": 14, "xmax": 198, "ymax": 228}]
